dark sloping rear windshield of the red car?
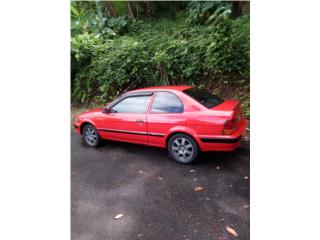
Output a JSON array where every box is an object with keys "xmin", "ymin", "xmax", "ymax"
[{"xmin": 183, "ymin": 88, "xmax": 224, "ymax": 108}]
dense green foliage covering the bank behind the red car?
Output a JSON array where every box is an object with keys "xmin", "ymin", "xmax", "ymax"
[{"xmin": 71, "ymin": 2, "xmax": 249, "ymax": 106}]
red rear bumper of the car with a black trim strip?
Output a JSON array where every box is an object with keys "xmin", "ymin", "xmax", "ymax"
[{"xmin": 198, "ymin": 119, "xmax": 247, "ymax": 151}]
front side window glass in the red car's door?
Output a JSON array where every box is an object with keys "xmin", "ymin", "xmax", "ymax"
[{"xmin": 111, "ymin": 96, "xmax": 151, "ymax": 113}]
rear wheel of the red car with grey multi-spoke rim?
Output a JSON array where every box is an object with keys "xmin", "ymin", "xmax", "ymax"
[{"xmin": 168, "ymin": 133, "xmax": 199, "ymax": 164}]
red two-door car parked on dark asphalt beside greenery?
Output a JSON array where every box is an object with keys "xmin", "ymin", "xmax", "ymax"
[{"xmin": 74, "ymin": 86, "xmax": 246, "ymax": 163}]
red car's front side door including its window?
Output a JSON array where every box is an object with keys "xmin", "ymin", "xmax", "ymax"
[{"xmin": 99, "ymin": 92, "xmax": 152, "ymax": 144}]
